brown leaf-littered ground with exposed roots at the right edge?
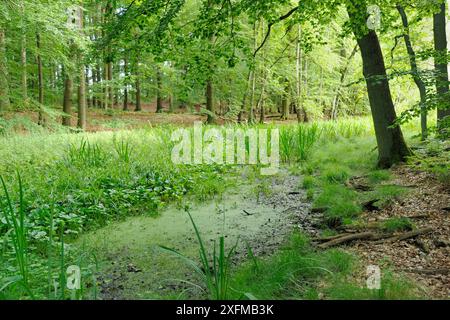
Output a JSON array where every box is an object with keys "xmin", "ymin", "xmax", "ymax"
[{"xmin": 350, "ymin": 166, "xmax": 450, "ymax": 298}]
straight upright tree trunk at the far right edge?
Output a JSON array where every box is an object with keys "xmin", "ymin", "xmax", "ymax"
[{"xmin": 433, "ymin": 2, "xmax": 450, "ymax": 127}]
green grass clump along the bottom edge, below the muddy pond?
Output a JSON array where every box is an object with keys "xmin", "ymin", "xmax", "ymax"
[{"xmin": 230, "ymin": 233, "xmax": 420, "ymax": 300}]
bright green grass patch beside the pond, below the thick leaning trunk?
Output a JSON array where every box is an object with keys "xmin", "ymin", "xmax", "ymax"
[{"xmin": 301, "ymin": 136, "xmax": 408, "ymax": 227}]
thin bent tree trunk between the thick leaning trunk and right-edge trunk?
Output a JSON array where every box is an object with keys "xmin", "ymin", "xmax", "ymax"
[{"xmin": 397, "ymin": 5, "xmax": 428, "ymax": 140}]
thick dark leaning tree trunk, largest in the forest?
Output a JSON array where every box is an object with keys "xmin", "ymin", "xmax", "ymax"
[{"xmin": 347, "ymin": 2, "xmax": 410, "ymax": 168}]
